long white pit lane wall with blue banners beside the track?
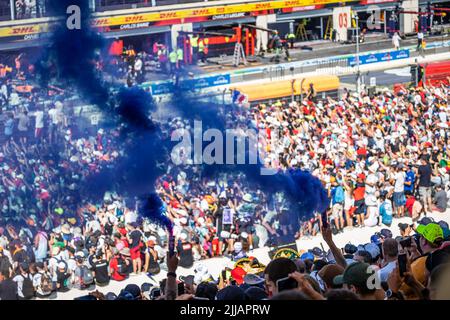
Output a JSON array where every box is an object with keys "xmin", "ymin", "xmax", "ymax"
[{"xmin": 142, "ymin": 40, "xmax": 450, "ymax": 99}]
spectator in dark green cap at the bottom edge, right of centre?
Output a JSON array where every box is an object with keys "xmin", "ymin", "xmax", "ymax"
[{"xmin": 333, "ymin": 262, "xmax": 382, "ymax": 300}]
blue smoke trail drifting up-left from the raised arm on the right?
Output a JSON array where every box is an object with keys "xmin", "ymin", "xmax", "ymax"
[{"xmin": 171, "ymin": 88, "xmax": 330, "ymax": 218}]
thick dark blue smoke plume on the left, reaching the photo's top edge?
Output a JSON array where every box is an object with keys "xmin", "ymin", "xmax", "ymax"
[{"xmin": 37, "ymin": 0, "xmax": 170, "ymax": 226}]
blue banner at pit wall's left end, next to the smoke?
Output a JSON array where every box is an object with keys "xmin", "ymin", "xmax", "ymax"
[{"xmin": 150, "ymin": 74, "xmax": 231, "ymax": 96}]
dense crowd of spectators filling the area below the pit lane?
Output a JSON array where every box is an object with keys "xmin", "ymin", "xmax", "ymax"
[{"xmin": 0, "ymin": 48, "xmax": 450, "ymax": 300}]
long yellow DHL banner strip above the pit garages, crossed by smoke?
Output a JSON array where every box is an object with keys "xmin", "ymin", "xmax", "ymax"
[{"xmin": 0, "ymin": 0, "xmax": 355, "ymax": 39}]
